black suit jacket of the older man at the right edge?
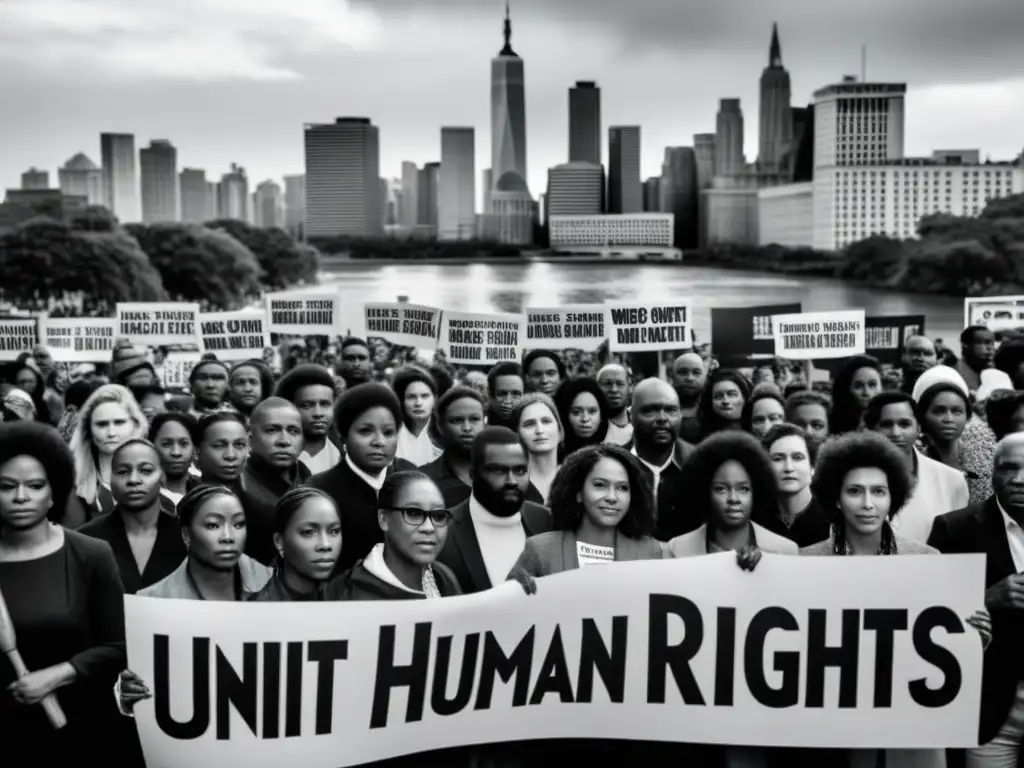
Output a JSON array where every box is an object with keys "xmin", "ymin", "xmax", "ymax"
[{"xmin": 928, "ymin": 497, "xmax": 1024, "ymax": 743}]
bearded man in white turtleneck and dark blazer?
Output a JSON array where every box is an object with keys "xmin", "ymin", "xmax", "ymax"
[{"xmin": 437, "ymin": 427, "xmax": 551, "ymax": 594}]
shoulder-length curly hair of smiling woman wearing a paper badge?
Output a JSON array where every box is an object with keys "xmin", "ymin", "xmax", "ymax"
[{"xmin": 549, "ymin": 443, "xmax": 654, "ymax": 539}]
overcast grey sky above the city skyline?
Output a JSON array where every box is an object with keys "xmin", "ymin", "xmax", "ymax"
[{"xmin": 0, "ymin": 0, "xmax": 1024, "ymax": 207}]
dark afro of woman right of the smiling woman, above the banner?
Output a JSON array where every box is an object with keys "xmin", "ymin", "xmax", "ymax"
[{"xmin": 679, "ymin": 430, "xmax": 778, "ymax": 523}]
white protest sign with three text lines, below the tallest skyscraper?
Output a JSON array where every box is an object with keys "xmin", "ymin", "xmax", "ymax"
[{"xmin": 440, "ymin": 311, "xmax": 526, "ymax": 366}]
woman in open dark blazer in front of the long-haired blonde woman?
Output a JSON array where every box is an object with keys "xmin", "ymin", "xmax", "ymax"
[{"xmin": 78, "ymin": 439, "xmax": 186, "ymax": 595}]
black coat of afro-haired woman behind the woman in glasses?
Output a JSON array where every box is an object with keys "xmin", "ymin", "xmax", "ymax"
[{"xmin": 306, "ymin": 459, "xmax": 416, "ymax": 575}]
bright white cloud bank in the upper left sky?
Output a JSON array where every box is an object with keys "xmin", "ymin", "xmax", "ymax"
[{"xmin": 0, "ymin": 0, "xmax": 381, "ymax": 82}]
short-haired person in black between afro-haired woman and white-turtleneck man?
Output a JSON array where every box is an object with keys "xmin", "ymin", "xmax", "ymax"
[{"xmin": 420, "ymin": 387, "xmax": 483, "ymax": 509}]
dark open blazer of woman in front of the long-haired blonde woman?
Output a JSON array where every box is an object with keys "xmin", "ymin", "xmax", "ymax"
[{"xmin": 78, "ymin": 505, "xmax": 187, "ymax": 595}]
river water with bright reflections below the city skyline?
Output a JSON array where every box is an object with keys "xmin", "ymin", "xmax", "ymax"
[{"xmin": 315, "ymin": 262, "xmax": 964, "ymax": 348}]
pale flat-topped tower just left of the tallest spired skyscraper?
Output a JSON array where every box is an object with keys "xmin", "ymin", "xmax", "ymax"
[{"xmin": 437, "ymin": 127, "xmax": 476, "ymax": 240}]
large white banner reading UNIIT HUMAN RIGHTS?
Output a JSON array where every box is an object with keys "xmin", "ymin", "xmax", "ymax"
[{"xmin": 125, "ymin": 553, "xmax": 984, "ymax": 768}]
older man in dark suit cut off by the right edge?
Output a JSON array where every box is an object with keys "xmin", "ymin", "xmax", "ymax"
[{"xmin": 928, "ymin": 432, "xmax": 1024, "ymax": 757}]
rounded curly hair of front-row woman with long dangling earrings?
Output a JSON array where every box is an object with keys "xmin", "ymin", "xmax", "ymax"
[{"xmin": 811, "ymin": 432, "xmax": 913, "ymax": 526}]
